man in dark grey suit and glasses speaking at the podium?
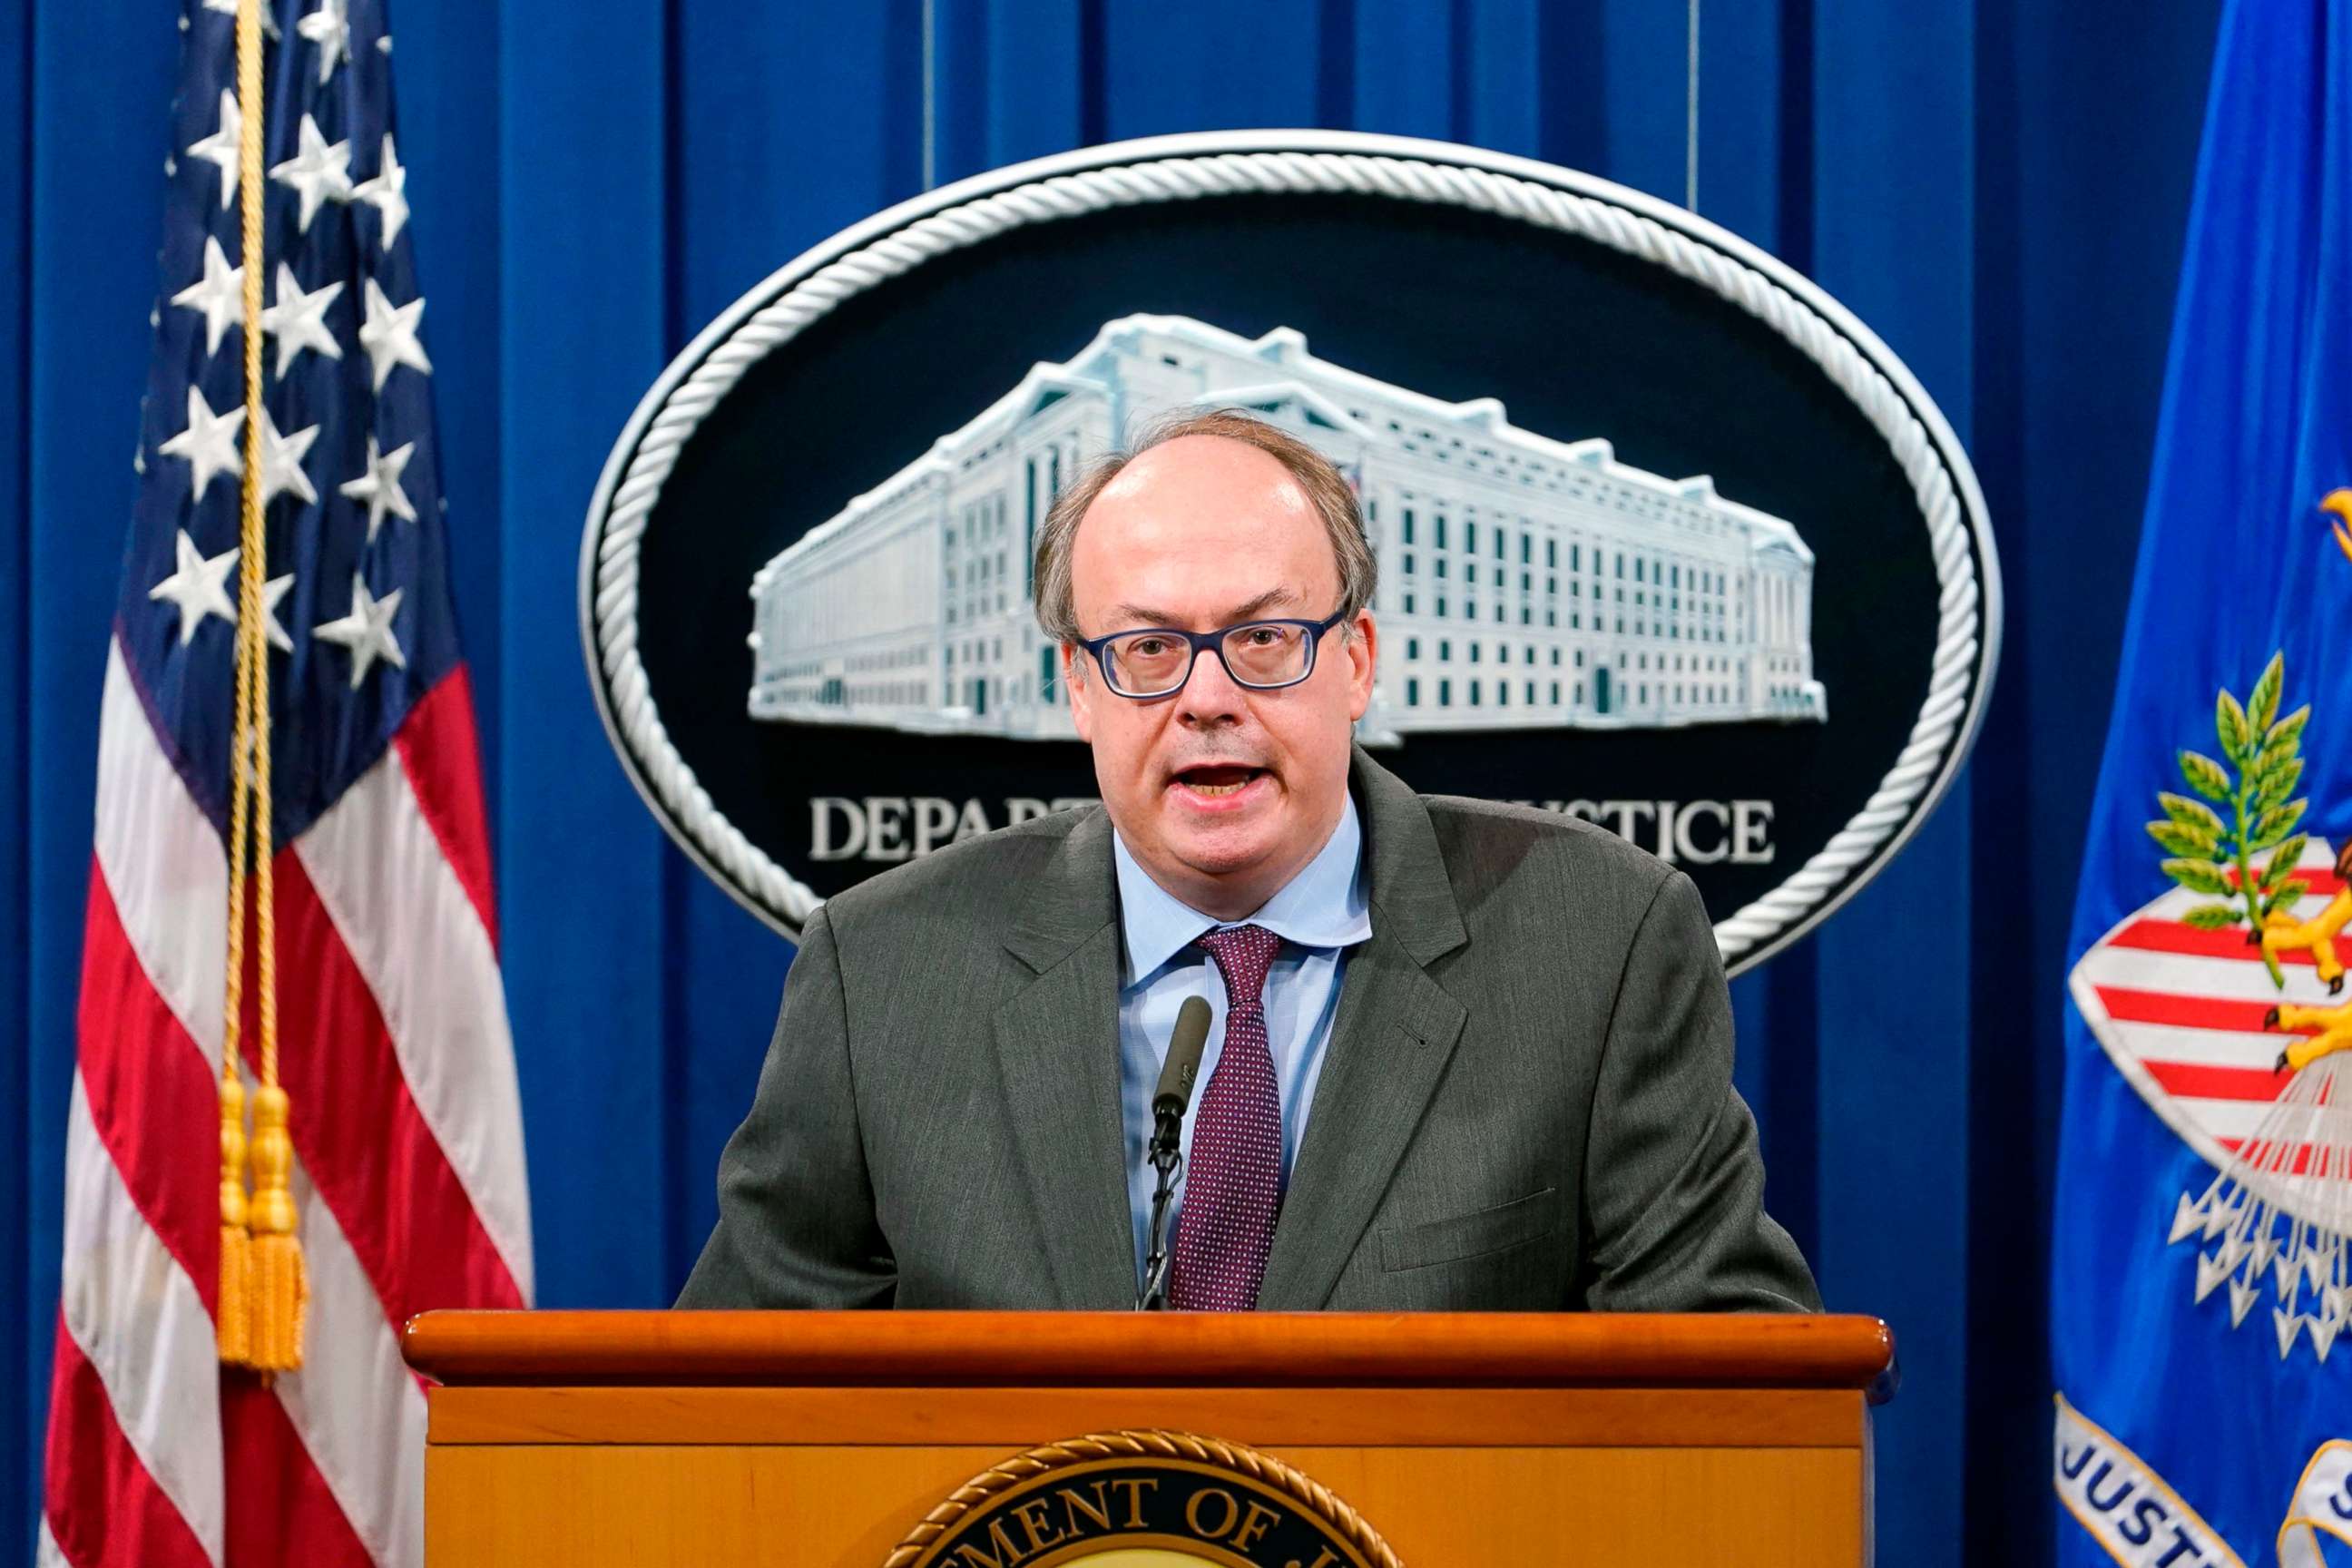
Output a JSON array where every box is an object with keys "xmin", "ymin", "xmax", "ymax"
[{"xmin": 680, "ymin": 411, "xmax": 1820, "ymax": 1312}]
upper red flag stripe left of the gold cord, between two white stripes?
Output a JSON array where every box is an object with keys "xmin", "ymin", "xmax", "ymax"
[{"xmin": 78, "ymin": 858, "xmax": 221, "ymax": 1312}]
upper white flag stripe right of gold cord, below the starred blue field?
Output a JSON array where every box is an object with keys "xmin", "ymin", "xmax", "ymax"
[{"xmin": 294, "ymin": 748, "xmax": 532, "ymax": 1302}]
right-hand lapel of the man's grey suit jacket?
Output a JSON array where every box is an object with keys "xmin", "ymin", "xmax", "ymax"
[{"xmin": 1260, "ymin": 750, "xmax": 1467, "ymax": 1312}]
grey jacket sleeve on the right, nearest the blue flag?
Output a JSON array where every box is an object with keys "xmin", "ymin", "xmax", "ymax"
[{"xmin": 1583, "ymin": 872, "xmax": 1820, "ymax": 1312}]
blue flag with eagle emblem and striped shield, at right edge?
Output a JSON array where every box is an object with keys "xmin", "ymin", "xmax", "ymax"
[{"xmin": 2051, "ymin": 0, "xmax": 2352, "ymax": 1568}]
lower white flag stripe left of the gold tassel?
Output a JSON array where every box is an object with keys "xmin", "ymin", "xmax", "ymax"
[{"xmin": 59, "ymin": 1072, "xmax": 223, "ymax": 1563}]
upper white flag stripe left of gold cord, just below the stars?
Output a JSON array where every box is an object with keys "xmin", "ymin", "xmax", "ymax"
[{"xmin": 94, "ymin": 642, "xmax": 228, "ymax": 1074}]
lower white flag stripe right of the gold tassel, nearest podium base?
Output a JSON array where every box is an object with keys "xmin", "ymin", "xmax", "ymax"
[{"xmin": 275, "ymin": 1166, "xmax": 426, "ymax": 1568}]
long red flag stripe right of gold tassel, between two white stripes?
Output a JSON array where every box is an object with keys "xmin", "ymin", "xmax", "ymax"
[{"xmin": 269, "ymin": 851, "xmax": 522, "ymax": 1324}]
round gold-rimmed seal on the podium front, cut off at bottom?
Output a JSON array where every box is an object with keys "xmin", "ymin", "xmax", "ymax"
[{"xmin": 882, "ymin": 1432, "xmax": 1402, "ymax": 1568}]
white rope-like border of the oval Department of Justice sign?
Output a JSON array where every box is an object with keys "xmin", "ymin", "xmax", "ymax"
[{"xmin": 583, "ymin": 151, "xmax": 1990, "ymax": 962}]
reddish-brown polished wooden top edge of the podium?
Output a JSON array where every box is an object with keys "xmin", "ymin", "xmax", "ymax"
[{"xmin": 402, "ymin": 1312, "xmax": 1894, "ymax": 1401}]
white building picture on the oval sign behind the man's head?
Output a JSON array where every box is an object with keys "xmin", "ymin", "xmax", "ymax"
[{"xmin": 748, "ymin": 315, "xmax": 1828, "ymax": 743}]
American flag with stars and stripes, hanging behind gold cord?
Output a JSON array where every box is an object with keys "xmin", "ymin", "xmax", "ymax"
[{"xmin": 37, "ymin": 0, "xmax": 532, "ymax": 1568}]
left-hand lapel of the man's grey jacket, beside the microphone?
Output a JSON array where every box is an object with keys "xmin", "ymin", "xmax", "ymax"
[{"xmin": 993, "ymin": 811, "xmax": 1136, "ymax": 1309}]
